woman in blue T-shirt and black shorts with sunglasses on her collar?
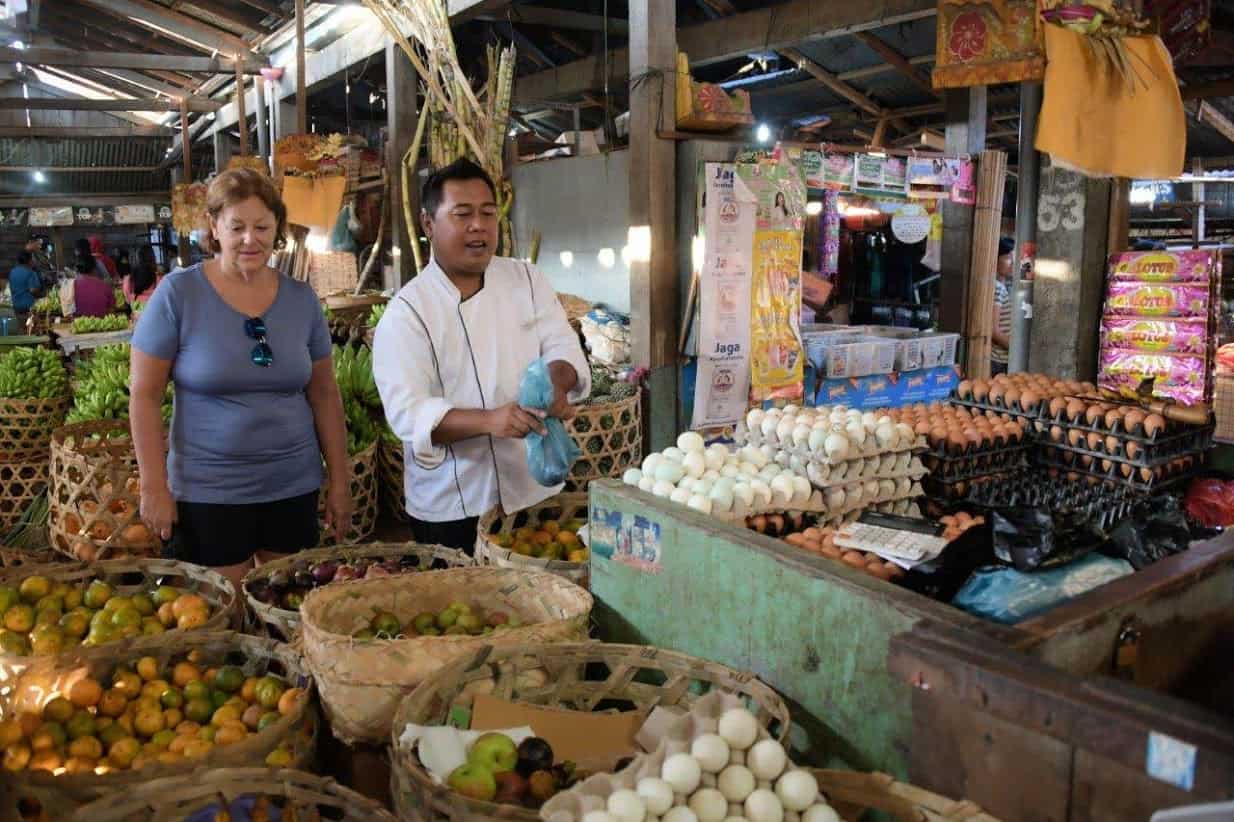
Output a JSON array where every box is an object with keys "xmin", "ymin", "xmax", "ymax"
[{"xmin": 128, "ymin": 169, "xmax": 353, "ymax": 583}]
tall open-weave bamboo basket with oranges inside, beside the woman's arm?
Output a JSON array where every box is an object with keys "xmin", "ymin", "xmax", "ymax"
[{"xmin": 48, "ymin": 420, "xmax": 160, "ymax": 562}]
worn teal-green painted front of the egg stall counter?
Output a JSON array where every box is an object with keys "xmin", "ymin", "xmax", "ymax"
[{"xmin": 590, "ymin": 483, "xmax": 1019, "ymax": 778}]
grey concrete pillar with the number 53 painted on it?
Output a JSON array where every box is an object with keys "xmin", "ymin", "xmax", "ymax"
[{"xmin": 1028, "ymin": 167, "xmax": 1111, "ymax": 380}]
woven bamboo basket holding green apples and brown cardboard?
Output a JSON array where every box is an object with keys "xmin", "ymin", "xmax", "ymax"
[{"xmin": 390, "ymin": 642, "xmax": 791, "ymax": 822}]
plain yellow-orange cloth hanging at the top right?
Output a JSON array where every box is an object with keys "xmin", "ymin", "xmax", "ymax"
[{"xmin": 1037, "ymin": 25, "xmax": 1187, "ymax": 179}]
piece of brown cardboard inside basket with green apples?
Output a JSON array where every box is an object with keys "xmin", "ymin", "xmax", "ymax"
[{"xmin": 471, "ymin": 694, "xmax": 644, "ymax": 773}]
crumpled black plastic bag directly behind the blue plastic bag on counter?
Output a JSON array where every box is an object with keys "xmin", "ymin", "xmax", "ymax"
[{"xmin": 992, "ymin": 507, "xmax": 1106, "ymax": 571}]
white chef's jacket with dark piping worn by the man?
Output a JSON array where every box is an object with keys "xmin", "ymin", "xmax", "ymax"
[{"xmin": 373, "ymin": 257, "xmax": 591, "ymax": 522}]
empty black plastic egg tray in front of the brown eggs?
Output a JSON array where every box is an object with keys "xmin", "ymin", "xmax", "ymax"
[{"xmin": 963, "ymin": 468, "xmax": 1141, "ymax": 531}]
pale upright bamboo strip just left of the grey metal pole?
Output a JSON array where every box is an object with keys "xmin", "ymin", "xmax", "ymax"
[{"xmin": 964, "ymin": 151, "xmax": 1007, "ymax": 379}]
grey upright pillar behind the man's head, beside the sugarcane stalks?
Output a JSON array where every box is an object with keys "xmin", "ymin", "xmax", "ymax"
[{"xmin": 383, "ymin": 41, "xmax": 420, "ymax": 289}]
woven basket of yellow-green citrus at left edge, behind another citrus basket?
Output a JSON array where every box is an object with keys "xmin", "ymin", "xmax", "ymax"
[{"xmin": 0, "ymin": 558, "xmax": 241, "ymax": 694}]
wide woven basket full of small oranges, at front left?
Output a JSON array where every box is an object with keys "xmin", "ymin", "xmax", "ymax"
[{"xmin": 0, "ymin": 631, "xmax": 317, "ymax": 820}]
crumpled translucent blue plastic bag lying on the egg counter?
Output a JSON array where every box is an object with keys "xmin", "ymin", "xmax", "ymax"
[{"xmin": 951, "ymin": 554, "xmax": 1133, "ymax": 625}]
